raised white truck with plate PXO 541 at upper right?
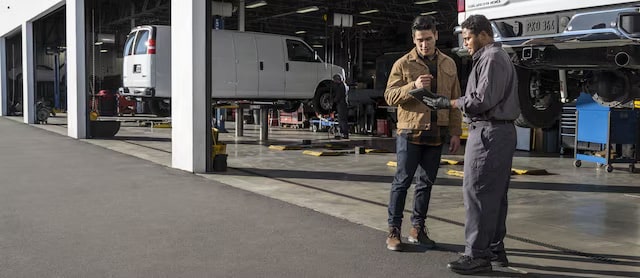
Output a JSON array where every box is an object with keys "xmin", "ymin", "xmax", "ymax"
[{"xmin": 455, "ymin": 0, "xmax": 640, "ymax": 127}]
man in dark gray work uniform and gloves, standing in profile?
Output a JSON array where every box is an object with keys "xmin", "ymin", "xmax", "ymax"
[{"xmin": 423, "ymin": 15, "xmax": 520, "ymax": 274}]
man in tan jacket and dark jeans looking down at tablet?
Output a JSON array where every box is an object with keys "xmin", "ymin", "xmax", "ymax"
[{"xmin": 384, "ymin": 16, "xmax": 462, "ymax": 251}]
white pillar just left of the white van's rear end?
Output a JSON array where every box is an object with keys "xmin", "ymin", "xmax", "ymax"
[{"xmin": 67, "ymin": 0, "xmax": 89, "ymax": 139}]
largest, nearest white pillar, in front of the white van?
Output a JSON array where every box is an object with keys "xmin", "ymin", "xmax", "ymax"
[{"xmin": 171, "ymin": 0, "xmax": 211, "ymax": 172}]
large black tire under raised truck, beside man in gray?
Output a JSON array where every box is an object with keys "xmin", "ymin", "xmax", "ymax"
[{"xmin": 515, "ymin": 67, "xmax": 562, "ymax": 128}]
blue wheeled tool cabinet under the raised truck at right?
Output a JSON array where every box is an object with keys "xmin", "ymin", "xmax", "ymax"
[{"xmin": 574, "ymin": 93, "xmax": 639, "ymax": 172}]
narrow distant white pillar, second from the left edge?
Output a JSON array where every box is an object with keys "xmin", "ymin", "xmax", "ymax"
[{"xmin": 22, "ymin": 22, "xmax": 36, "ymax": 124}]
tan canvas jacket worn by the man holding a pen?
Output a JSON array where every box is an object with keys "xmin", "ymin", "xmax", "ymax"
[{"xmin": 384, "ymin": 48, "xmax": 462, "ymax": 136}]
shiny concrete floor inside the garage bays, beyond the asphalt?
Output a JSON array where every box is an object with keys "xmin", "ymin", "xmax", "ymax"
[{"xmin": 10, "ymin": 114, "xmax": 640, "ymax": 277}]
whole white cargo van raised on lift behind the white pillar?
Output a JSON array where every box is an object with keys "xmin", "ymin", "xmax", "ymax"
[{"xmin": 120, "ymin": 25, "xmax": 345, "ymax": 116}]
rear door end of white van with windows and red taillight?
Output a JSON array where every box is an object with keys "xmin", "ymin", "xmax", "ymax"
[{"xmin": 123, "ymin": 26, "xmax": 156, "ymax": 91}]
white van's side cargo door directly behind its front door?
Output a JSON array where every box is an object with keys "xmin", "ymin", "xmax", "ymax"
[{"xmin": 256, "ymin": 35, "xmax": 285, "ymax": 99}]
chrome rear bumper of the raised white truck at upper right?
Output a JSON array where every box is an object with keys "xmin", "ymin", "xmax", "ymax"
[{"xmin": 453, "ymin": 7, "xmax": 640, "ymax": 69}]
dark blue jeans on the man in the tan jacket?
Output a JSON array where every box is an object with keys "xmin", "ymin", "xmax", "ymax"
[{"xmin": 388, "ymin": 136, "xmax": 442, "ymax": 227}]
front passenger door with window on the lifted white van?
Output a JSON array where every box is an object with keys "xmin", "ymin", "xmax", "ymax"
[{"xmin": 285, "ymin": 39, "xmax": 322, "ymax": 99}]
